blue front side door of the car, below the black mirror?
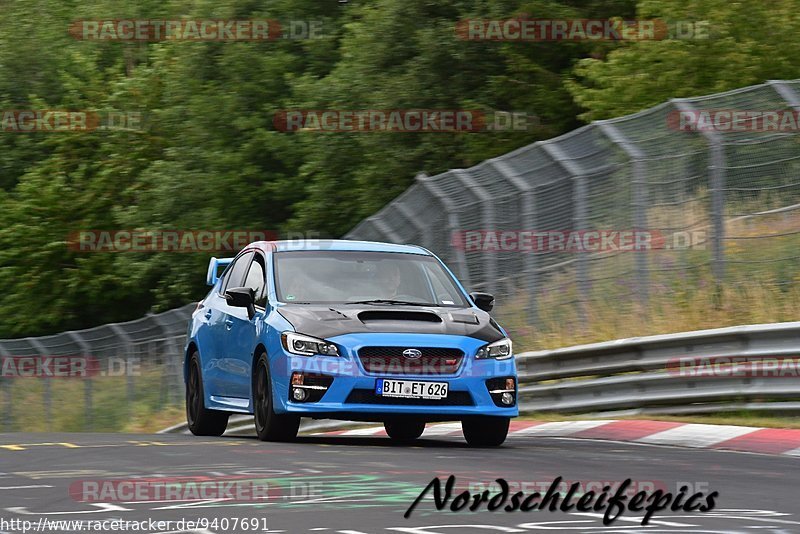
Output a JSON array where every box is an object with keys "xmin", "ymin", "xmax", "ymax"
[{"xmin": 223, "ymin": 252, "xmax": 267, "ymax": 401}]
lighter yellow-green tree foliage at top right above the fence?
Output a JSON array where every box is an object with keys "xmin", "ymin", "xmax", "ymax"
[{"xmin": 567, "ymin": 0, "xmax": 800, "ymax": 121}]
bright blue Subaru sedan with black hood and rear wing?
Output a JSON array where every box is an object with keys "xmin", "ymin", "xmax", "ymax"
[{"xmin": 184, "ymin": 240, "xmax": 518, "ymax": 447}]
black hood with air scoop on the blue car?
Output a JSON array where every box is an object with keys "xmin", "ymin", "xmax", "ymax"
[{"xmin": 277, "ymin": 304, "xmax": 505, "ymax": 343}]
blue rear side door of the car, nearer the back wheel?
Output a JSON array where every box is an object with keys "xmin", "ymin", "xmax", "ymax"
[{"xmin": 208, "ymin": 250, "xmax": 255, "ymax": 400}]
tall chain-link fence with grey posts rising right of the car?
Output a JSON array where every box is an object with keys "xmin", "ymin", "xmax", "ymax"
[{"xmin": 346, "ymin": 81, "xmax": 800, "ymax": 325}]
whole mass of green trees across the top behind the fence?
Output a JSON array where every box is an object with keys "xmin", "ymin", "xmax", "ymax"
[{"xmin": 0, "ymin": 0, "xmax": 800, "ymax": 337}]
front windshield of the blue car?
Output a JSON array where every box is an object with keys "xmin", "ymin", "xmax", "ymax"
[{"xmin": 274, "ymin": 250, "xmax": 468, "ymax": 307}]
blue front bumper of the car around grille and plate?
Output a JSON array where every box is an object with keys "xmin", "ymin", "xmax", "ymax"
[{"xmin": 271, "ymin": 333, "xmax": 519, "ymax": 421}]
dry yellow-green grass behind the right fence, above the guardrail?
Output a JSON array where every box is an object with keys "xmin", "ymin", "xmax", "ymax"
[{"xmin": 499, "ymin": 207, "xmax": 800, "ymax": 352}]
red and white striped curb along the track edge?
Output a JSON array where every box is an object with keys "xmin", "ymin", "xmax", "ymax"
[{"xmin": 314, "ymin": 420, "xmax": 800, "ymax": 457}]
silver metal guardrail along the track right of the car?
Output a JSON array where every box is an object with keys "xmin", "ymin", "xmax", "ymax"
[{"xmin": 162, "ymin": 322, "xmax": 800, "ymax": 435}]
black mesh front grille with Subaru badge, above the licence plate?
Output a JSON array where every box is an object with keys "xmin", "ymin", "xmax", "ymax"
[{"xmin": 358, "ymin": 347, "xmax": 464, "ymax": 375}]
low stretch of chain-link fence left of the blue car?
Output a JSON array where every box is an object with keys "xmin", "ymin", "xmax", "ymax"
[{"xmin": 0, "ymin": 304, "xmax": 195, "ymax": 432}]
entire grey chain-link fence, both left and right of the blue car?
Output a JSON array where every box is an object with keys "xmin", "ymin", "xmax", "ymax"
[{"xmin": 0, "ymin": 81, "xmax": 800, "ymax": 431}]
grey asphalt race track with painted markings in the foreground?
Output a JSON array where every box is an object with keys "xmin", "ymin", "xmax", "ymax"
[{"xmin": 0, "ymin": 434, "xmax": 800, "ymax": 534}]
